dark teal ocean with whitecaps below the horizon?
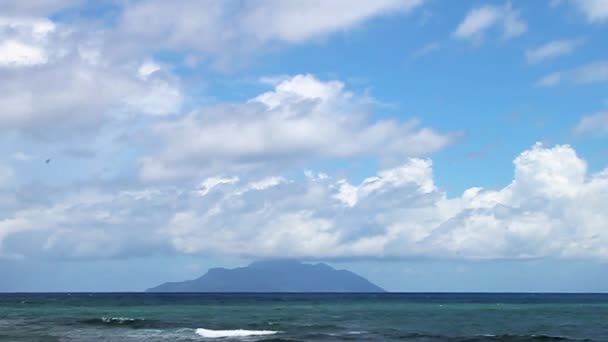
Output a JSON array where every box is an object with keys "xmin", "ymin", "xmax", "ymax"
[{"xmin": 0, "ymin": 293, "xmax": 608, "ymax": 342}]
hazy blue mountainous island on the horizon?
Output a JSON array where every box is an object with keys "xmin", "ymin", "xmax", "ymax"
[{"xmin": 147, "ymin": 259, "xmax": 384, "ymax": 292}]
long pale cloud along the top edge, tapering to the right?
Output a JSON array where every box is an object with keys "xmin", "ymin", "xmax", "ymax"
[{"xmin": 117, "ymin": 0, "xmax": 423, "ymax": 66}]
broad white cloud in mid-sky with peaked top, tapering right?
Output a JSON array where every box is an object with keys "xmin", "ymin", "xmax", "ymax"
[{"xmin": 141, "ymin": 75, "xmax": 454, "ymax": 180}]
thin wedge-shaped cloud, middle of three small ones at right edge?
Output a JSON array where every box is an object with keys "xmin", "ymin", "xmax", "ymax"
[{"xmin": 536, "ymin": 60, "xmax": 608, "ymax": 87}]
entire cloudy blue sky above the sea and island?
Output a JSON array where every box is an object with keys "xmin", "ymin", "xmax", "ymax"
[{"xmin": 0, "ymin": 0, "xmax": 608, "ymax": 291}]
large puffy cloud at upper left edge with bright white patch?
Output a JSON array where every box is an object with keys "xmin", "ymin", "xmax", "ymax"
[{"xmin": 0, "ymin": 17, "xmax": 183, "ymax": 139}]
